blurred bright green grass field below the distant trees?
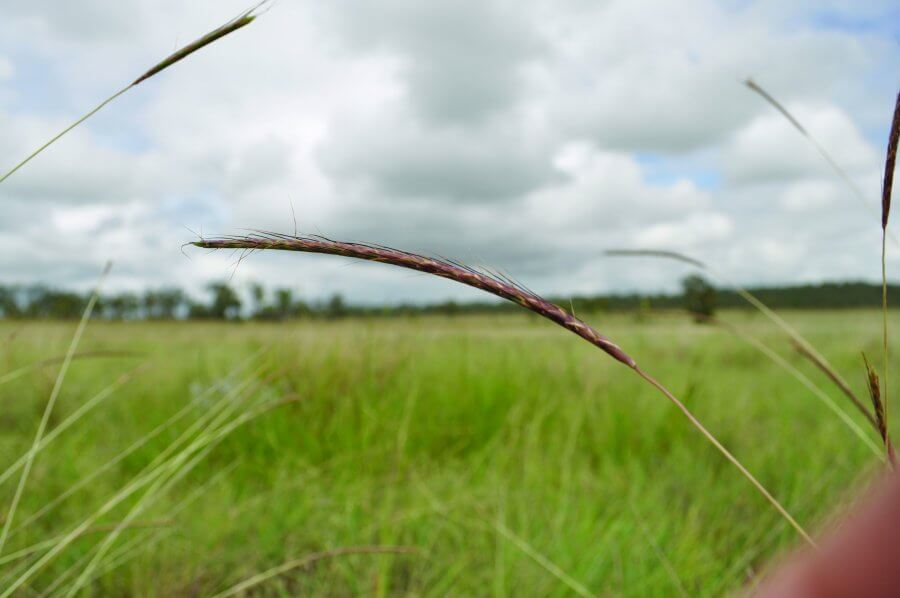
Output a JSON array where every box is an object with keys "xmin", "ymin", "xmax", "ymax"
[{"xmin": 0, "ymin": 311, "xmax": 888, "ymax": 596}]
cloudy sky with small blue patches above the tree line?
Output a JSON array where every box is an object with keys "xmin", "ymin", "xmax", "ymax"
[{"xmin": 0, "ymin": 0, "xmax": 900, "ymax": 304}]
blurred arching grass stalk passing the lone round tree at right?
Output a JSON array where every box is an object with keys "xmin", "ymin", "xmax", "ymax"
[{"xmin": 605, "ymin": 249, "xmax": 875, "ymax": 427}]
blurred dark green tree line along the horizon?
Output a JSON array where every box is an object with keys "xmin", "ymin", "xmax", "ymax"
[{"xmin": 0, "ymin": 276, "xmax": 900, "ymax": 321}]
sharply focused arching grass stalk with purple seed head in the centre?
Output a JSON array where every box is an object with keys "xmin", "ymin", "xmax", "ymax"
[{"xmin": 192, "ymin": 233, "xmax": 815, "ymax": 546}]
